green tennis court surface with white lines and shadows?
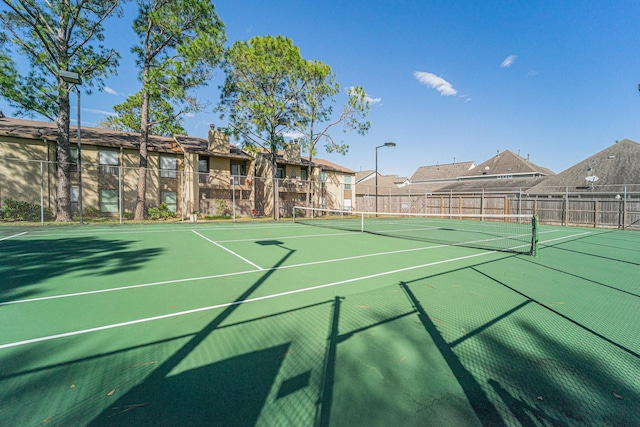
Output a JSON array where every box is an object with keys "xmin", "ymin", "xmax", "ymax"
[{"xmin": 0, "ymin": 222, "xmax": 640, "ymax": 426}]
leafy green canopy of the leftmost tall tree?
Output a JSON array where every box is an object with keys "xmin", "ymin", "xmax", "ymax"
[{"xmin": 0, "ymin": 0, "xmax": 122, "ymax": 120}]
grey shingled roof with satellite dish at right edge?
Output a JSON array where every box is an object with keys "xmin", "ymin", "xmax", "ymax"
[{"xmin": 527, "ymin": 139, "xmax": 640, "ymax": 193}]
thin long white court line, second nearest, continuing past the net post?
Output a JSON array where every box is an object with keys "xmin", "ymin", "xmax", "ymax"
[{"xmin": 0, "ymin": 230, "xmax": 590, "ymax": 307}]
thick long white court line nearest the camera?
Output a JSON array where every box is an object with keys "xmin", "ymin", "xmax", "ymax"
[{"xmin": 0, "ymin": 251, "xmax": 496, "ymax": 350}]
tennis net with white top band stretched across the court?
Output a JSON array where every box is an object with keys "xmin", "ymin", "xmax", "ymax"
[{"xmin": 293, "ymin": 206, "xmax": 538, "ymax": 255}]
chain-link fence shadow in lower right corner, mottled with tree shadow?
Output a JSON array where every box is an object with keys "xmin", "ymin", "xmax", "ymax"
[{"xmin": 400, "ymin": 254, "xmax": 640, "ymax": 426}]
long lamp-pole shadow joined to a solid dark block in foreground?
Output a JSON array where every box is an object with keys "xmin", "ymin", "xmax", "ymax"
[{"xmin": 89, "ymin": 241, "xmax": 295, "ymax": 426}]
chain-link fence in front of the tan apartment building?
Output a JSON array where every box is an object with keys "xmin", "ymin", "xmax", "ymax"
[{"xmin": 0, "ymin": 159, "xmax": 344, "ymax": 223}]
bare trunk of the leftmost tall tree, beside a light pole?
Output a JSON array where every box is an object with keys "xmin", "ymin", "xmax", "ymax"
[{"xmin": 56, "ymin": 83, "xmax": 72, "ymax": 222}]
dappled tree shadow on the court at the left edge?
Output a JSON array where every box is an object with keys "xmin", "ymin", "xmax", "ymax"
[{"xmin": 0, "ymin": 237, "xmax": 163, "ymax": 300}]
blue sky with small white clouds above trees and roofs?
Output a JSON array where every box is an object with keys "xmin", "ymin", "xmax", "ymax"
[{"xmin": 0, "ymin": 0, "xmax": 640, "ymax": 176}]
